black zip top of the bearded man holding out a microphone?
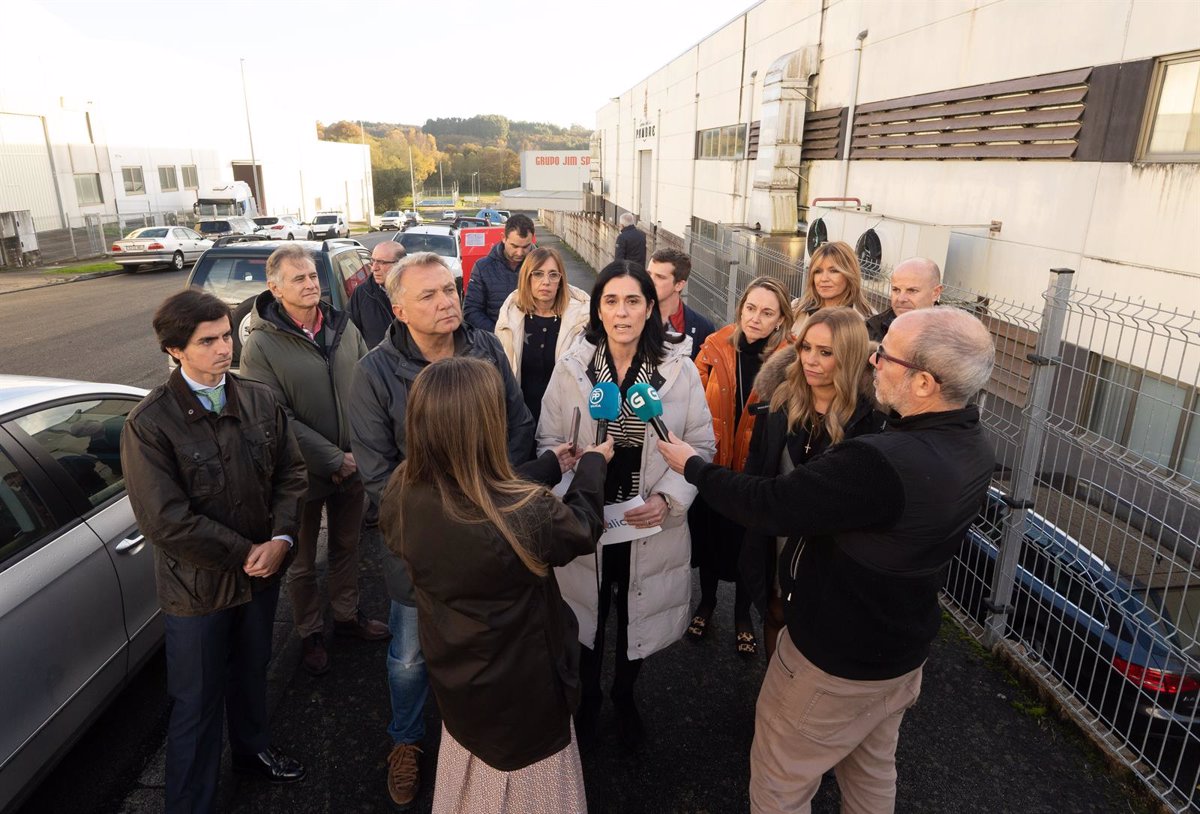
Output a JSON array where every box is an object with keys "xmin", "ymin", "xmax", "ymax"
[{"xmin": 684, "ymin": 406, "xmax": 996, "ymax": 681}]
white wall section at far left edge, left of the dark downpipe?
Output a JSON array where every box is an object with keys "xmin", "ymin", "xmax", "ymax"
[{"xmin": 0, "ymin": 113, "xmax": 62, "ymax": 231}]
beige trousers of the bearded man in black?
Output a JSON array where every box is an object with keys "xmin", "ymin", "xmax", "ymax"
[{"xmin": 750, "ymin": 628, "xmax": 922, "ymax": 814}]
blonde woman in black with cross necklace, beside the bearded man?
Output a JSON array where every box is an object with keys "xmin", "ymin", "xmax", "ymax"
[{"xmin": 738, "ymin": 307, "xmax": 883, "ymax": 659}]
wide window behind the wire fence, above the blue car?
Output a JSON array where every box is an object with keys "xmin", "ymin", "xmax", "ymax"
[{"xmin": 1081, "ymin": 357, "xmax": 1200, "ymax": 484}]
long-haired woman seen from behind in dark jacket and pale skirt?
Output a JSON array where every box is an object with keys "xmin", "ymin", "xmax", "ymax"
[{"xmin": 380, "ymin": 357, "xmax": 612, "ymax": 813}]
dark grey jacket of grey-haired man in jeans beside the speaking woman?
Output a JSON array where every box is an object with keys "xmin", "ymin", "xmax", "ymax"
[{"xmin": 350, "ymin": 319, "xmax": 549, "ymax": 605}]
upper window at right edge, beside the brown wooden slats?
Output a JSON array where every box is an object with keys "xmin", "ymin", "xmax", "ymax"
[{"xmin": 1141, "ymin": 52, "xmax": 1200, "ymax": 161}]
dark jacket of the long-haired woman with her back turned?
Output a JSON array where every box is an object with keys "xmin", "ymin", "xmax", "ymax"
[{"xmin": 379, "ymin": 454, "xmax": 605, "ymax": 772}]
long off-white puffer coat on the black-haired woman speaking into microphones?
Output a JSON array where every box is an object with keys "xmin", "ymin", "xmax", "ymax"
[{"xmin": 538, "ymin": 339, "xmax": 716, "ymax": 659}]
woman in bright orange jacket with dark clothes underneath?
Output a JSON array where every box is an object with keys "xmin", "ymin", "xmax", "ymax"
[{"xmin": 688, "ymin": 277, "xmax": 792, "ymax": 658}]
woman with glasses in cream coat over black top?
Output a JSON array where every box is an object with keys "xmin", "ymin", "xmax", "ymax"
[{"xmin": 496, "ymin": 247, "xmax": 588, "ymax": 425}]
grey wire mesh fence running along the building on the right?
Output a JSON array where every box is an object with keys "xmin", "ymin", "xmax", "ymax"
[{"xmin": 552, "ymin": 212, "xmax": 1200, "ymax": 812}]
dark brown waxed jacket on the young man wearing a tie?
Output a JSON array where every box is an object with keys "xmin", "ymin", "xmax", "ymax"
[{"xmin": 121, "ymin": 369, "xmax": 307, "ymax": 616}]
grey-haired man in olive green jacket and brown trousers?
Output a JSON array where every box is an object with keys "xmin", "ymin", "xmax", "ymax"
[{"xmin": 234, "ymin": 245, "xmax": 389, "ymax": 676}]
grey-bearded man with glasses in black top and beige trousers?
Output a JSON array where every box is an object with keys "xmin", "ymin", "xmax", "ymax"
[{"xmin": 659, "ymin": 306, "xmax": 995, "ymax": 813}]
